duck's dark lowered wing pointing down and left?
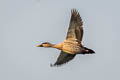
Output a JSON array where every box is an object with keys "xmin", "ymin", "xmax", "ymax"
[{"xmin": 51, "ymin": 51, "xmax": 76, "ymax": 66}]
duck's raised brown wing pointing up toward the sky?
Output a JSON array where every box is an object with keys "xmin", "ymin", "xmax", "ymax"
[{"xmin": 66, "ymin": 9, "xmax": 83, "ymax": 41}]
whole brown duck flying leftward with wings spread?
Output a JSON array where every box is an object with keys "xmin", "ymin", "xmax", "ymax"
[{"xmin": 37, "ymin": 9, "xmax": 95, "ymax": 67}]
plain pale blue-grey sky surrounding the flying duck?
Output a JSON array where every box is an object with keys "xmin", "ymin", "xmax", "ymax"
[{"xmin": 0, "ymin": 0, "xmax": 120, "ymax": 80}]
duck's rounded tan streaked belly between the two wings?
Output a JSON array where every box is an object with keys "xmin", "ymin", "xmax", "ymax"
[{"xmin": 63, "ymin": 43, "xmax": 81, "ymax": 54}]
